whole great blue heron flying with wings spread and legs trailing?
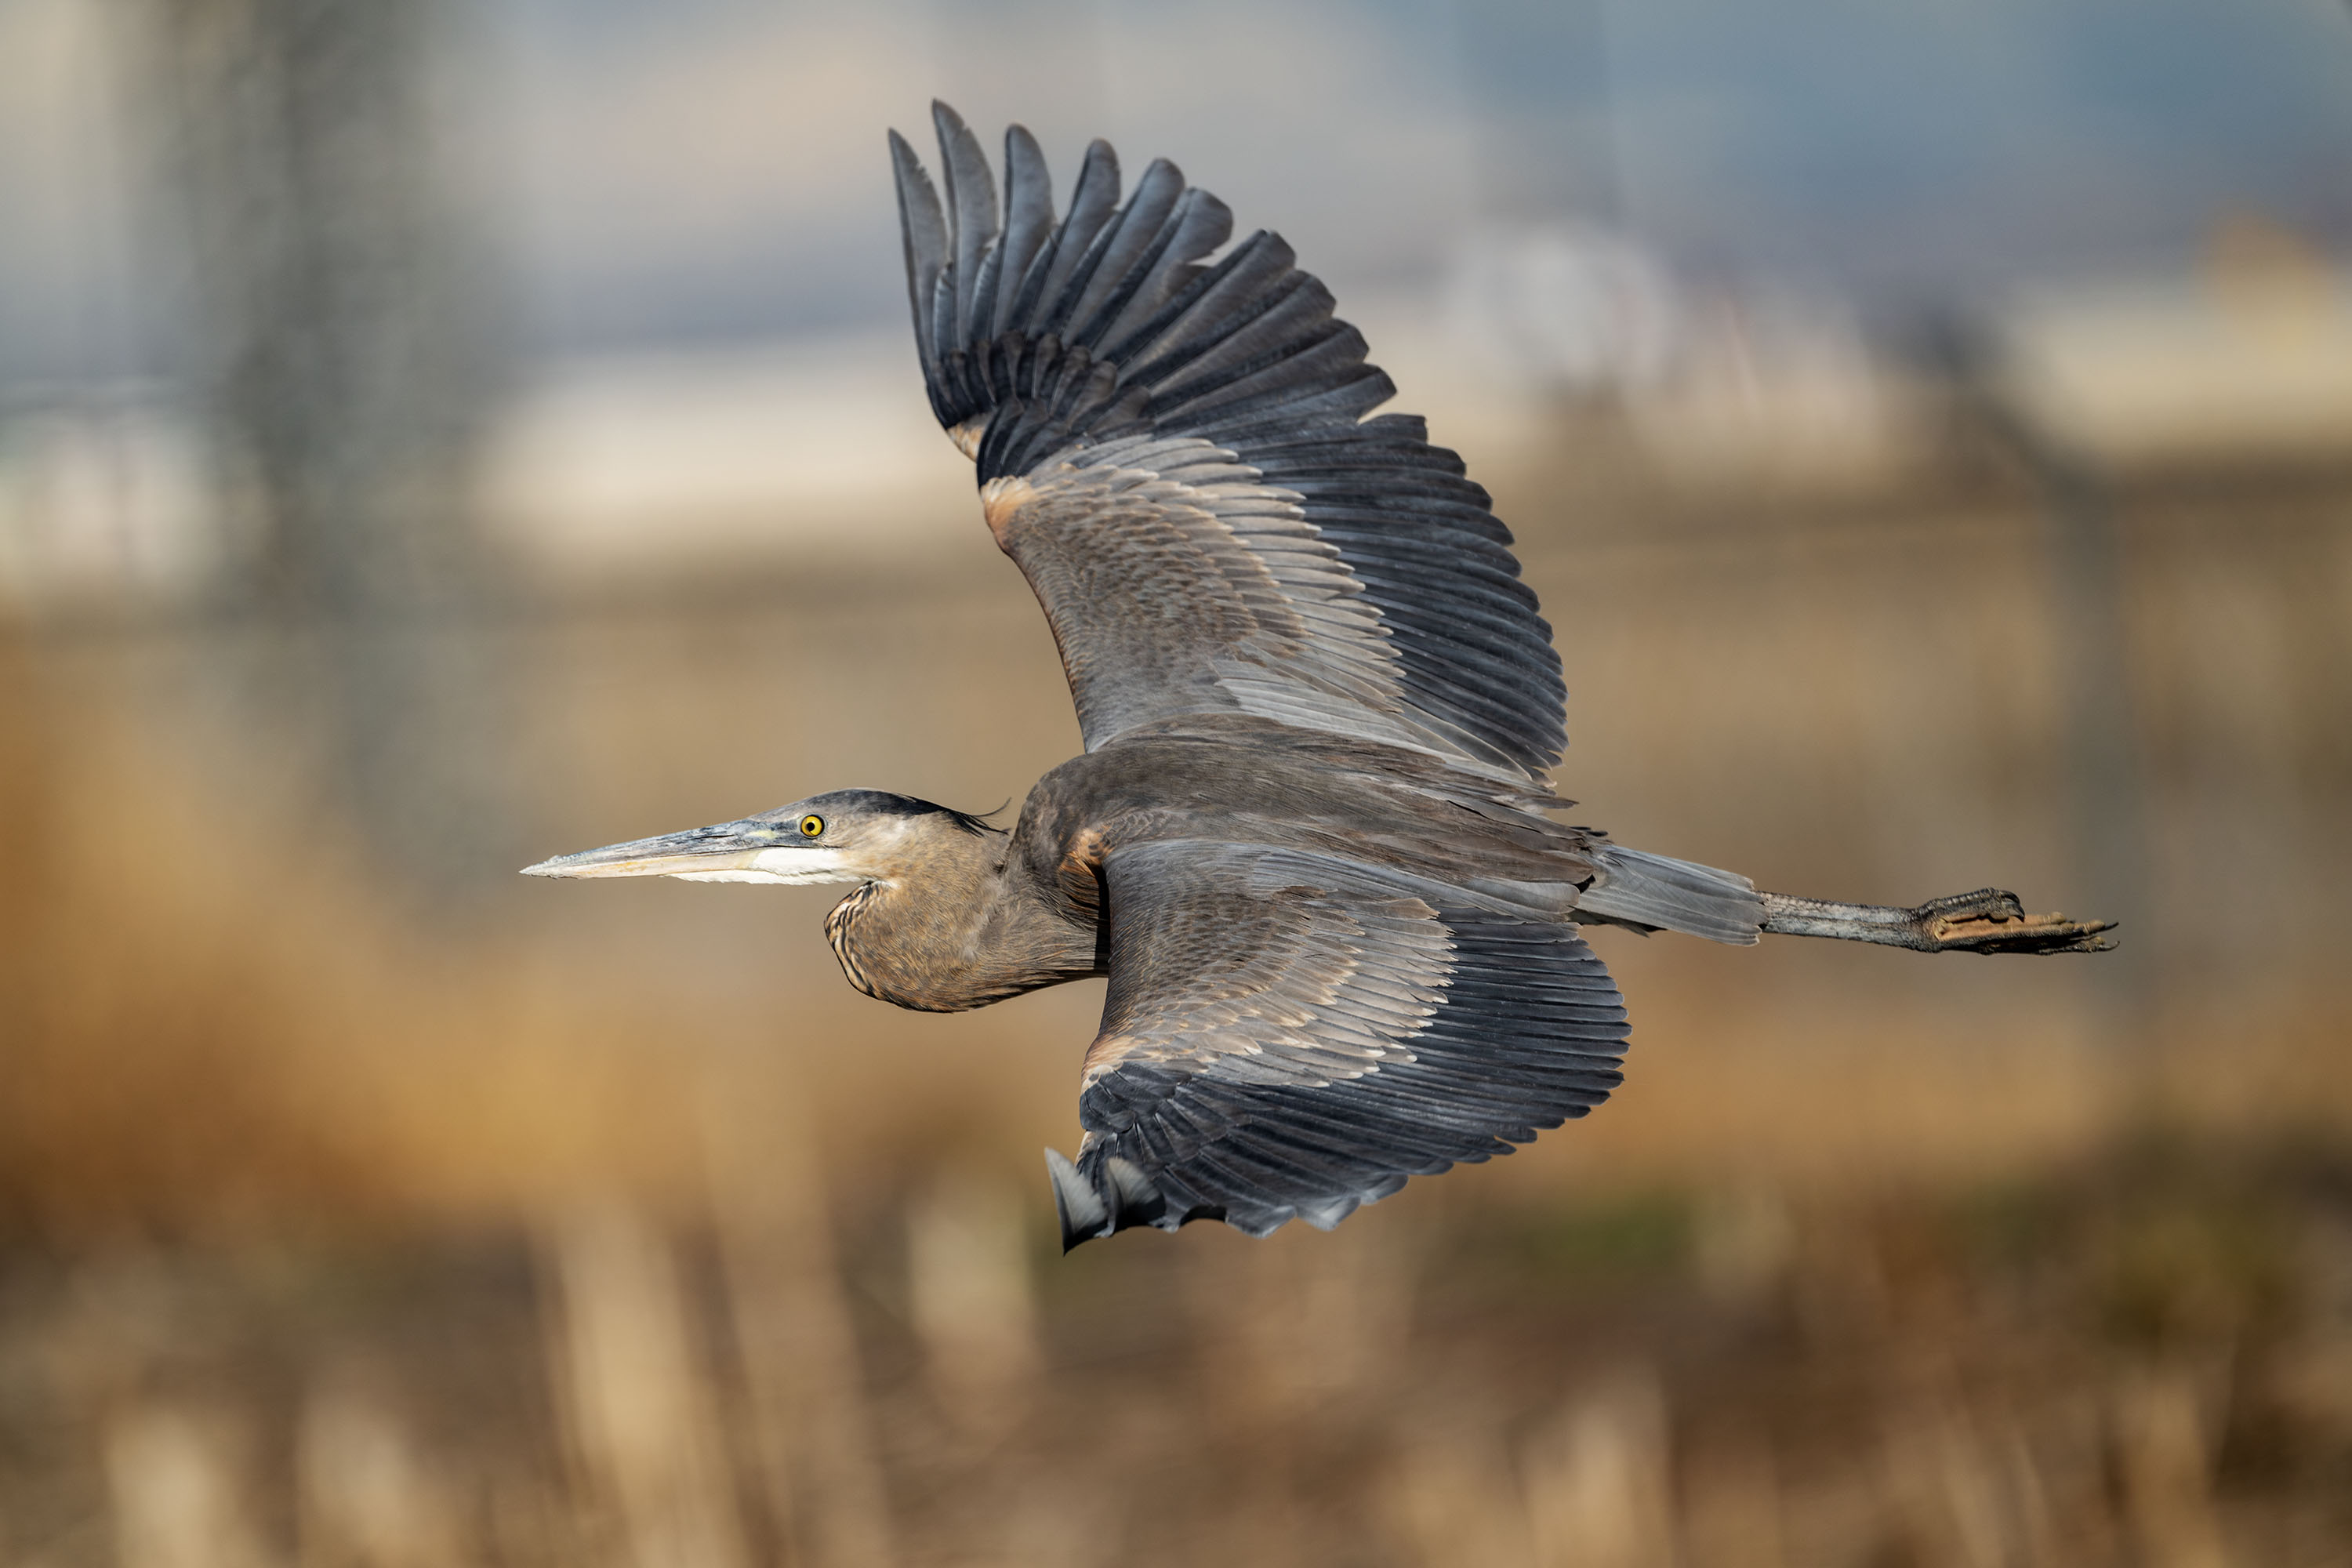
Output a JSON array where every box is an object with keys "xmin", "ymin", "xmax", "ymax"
[{"xmin": 529, "ymin": 103, "xmax": 2110, "ymax": 1248}]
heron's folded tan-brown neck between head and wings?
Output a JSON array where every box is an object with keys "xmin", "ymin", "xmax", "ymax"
[{"xmin": 826, "ymin": 832, "xmax": 1096, "ymax": 1013}]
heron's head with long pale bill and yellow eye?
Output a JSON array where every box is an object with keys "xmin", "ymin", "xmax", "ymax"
[{"xmin": 522, "ymin": 789, "xmax": 997, "ymax": 884}]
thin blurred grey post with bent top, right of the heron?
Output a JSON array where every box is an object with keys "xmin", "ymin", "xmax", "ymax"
[{"xmin": 1926, "ymin": 320, "xmax": 2157, "ymax": 1039}]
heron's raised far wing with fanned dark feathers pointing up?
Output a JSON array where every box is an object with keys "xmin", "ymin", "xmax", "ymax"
[{"xmin": 891, "ymin": 103, "xmax": 1566, "ymax": 783}]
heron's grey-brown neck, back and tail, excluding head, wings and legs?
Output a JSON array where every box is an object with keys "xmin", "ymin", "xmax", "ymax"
[{"xmin": 826, "ymin": 715, "xmax": 1764, "ymax": 1013}]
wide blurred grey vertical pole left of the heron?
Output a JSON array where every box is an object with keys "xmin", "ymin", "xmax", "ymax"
[{"xmin": 148, "ymin": 0, "xmax": 513, "ymax": 900}]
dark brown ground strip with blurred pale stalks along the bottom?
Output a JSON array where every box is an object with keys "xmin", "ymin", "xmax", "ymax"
[{"xmin": 0, "ymin": 1142, "xmax": 2352, "ymax": 1566}]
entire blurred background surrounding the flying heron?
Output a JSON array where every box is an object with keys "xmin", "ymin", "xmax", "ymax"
[{"xmin": 0, "ymin": 0, "xmax": 2352, "ymax": 1568}]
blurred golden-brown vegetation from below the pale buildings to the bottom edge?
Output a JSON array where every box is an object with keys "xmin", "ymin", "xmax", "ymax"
[{"xmin": 0, "ymin": 423, "xmax": 2352, "ymax": 1568}]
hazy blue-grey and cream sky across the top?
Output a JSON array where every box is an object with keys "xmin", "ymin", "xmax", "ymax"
[{"xmin": 0, "ymin": 0, "xmax": 2352, "ymax": 379}]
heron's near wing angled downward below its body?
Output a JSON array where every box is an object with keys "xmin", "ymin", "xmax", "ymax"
[{"xmin": 1047, "ymin": 841, "xmax": 1625, "ymax": 1246}]
